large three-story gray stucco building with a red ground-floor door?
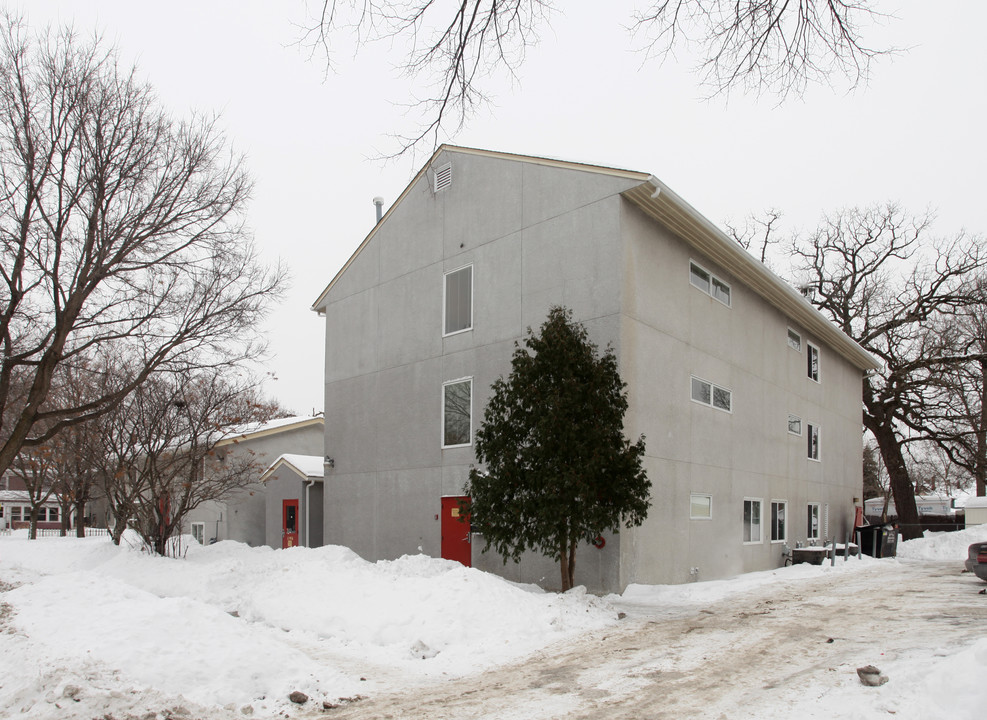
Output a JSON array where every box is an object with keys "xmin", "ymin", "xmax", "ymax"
[{"xmin": 314, "ymin": 145, "xmax": 876, "ymax": 591}]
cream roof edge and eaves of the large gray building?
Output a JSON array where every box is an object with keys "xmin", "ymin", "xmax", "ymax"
[{"xmin": 312, "ymin": 145, "xmax": 880, "ymax": 370}]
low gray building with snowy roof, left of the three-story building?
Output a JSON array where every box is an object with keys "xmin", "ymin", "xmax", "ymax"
[{"xmin": 183, "ymin": 416, "xmax": 324, "ymax": 548}]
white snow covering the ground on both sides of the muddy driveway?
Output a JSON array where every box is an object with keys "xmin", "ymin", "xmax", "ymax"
[{"xmin": 0, "ymin": 526, "xmax": 987, "ymax": 720}]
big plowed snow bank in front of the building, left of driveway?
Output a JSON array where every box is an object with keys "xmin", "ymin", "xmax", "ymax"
[{"xmin": 0, "ymin": 538, "xmax": 616, "ymax": 720}]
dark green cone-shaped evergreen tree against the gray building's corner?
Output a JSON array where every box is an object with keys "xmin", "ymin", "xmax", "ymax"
[{"xmin": 466, "ymin": 307, "xmax": 651, "ymax": 591}]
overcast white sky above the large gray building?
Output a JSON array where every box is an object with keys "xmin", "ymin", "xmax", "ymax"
[{"xmin": 15, "ymin": 0, "xmax": 987, "ymax": 413}]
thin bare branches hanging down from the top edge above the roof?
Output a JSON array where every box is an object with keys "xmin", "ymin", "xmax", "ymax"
[{"xmin": 302, "ymin": 0, "xmax": 893, "ymax": 154}]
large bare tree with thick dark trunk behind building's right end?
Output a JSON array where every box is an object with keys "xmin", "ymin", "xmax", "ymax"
[{"xmin": 793, "ymin": 205, "xmax": 985, "ymax": 539}]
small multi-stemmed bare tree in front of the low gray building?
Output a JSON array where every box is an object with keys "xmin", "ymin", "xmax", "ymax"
[{"xmin": 97, "ymin": 369, "xmax": 279, "ymax": 554}]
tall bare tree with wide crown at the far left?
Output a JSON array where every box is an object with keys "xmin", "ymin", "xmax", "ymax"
[{"xmin": 0, "ymin": 16, "xmax": 284, "ymax": 472}]
